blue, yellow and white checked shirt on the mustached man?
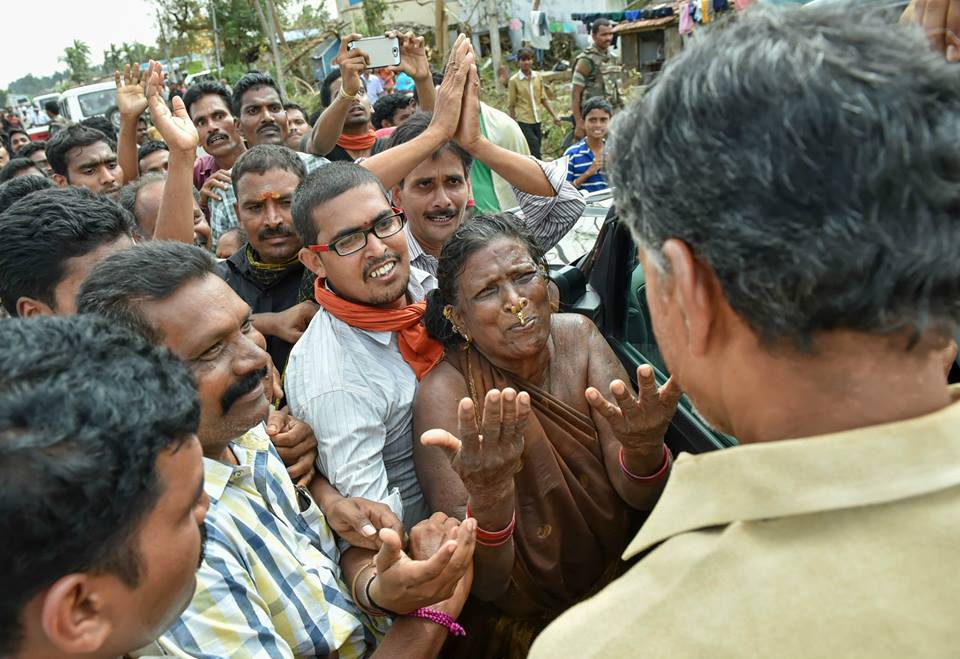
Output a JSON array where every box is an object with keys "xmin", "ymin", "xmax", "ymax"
[{"xmin": 137, "ymin": 424, "xmax": 386, "ymax": 659}]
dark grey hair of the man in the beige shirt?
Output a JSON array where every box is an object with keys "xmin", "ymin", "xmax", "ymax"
[{"xmin": 611, "ymin": 2, "xmax": 960, "ymax": 350}]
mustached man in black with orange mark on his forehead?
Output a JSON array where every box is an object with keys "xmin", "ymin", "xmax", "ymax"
[{"xmin": 217, "ymin": 144, "xmax": 317, "ymax": 373}]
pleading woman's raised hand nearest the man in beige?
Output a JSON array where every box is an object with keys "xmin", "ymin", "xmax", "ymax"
[{"xmin": 586, "ymin": 364, "xmax": 683, "ymax": 451}]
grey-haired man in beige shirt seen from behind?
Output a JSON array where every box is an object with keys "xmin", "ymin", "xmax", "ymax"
[{"xmin": 531, "ymin": 3, "xmax": 960, "ymax": 657}]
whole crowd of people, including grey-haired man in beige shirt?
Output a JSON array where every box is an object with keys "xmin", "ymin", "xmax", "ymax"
[{"xmin": 0, "ymin": 0, "xmax": 960, "ymax": 658}]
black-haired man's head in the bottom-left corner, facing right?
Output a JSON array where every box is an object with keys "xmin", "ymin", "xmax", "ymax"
[{"xmin": 0, "ymin": 315, "xmax": 208, "ymax": 659}]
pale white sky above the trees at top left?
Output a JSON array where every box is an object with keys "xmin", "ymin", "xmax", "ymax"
[{"xmin": 0, "ymin": 0, "xmax": 158, "ymax": 89}]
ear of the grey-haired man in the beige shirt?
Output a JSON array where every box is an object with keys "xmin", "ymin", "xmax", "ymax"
[{"xmin": 662, "ymin": 239, "xmax": 726, "ymax": 357}]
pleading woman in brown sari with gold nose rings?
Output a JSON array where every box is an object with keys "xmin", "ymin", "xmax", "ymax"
[{"xmin": 414, "ymin": 215, "xmax": 680, "ymax": 657}]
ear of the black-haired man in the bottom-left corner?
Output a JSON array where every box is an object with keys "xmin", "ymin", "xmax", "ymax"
[{"xmin": 39, "ymin": 574, "xmax": 113, "ymax": 655}]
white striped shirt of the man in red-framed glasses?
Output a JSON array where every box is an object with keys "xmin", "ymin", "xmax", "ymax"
[{"xmin": 284, "ymin": 267, "xmax": 433, "ymax": 529}]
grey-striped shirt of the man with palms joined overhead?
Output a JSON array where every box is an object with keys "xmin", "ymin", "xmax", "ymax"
[{"xmin": 404, "ymin": 156, "xmax": 587, "ymax": 284}]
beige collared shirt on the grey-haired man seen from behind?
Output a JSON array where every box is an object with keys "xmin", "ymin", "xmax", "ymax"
[{"xmin": 530, "ymin": 388, "xmax": 960, "ymax": 659}]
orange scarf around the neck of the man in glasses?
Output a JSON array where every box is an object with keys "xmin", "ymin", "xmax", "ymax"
[{"xmin": 313, "ymin": 277, "xmax": 443, "ymax": 380}]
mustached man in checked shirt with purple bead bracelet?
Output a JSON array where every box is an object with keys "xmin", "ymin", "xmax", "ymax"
[{"xmin": 78, "ymin": 241, "xmax": 475, "ymax": 658}]
